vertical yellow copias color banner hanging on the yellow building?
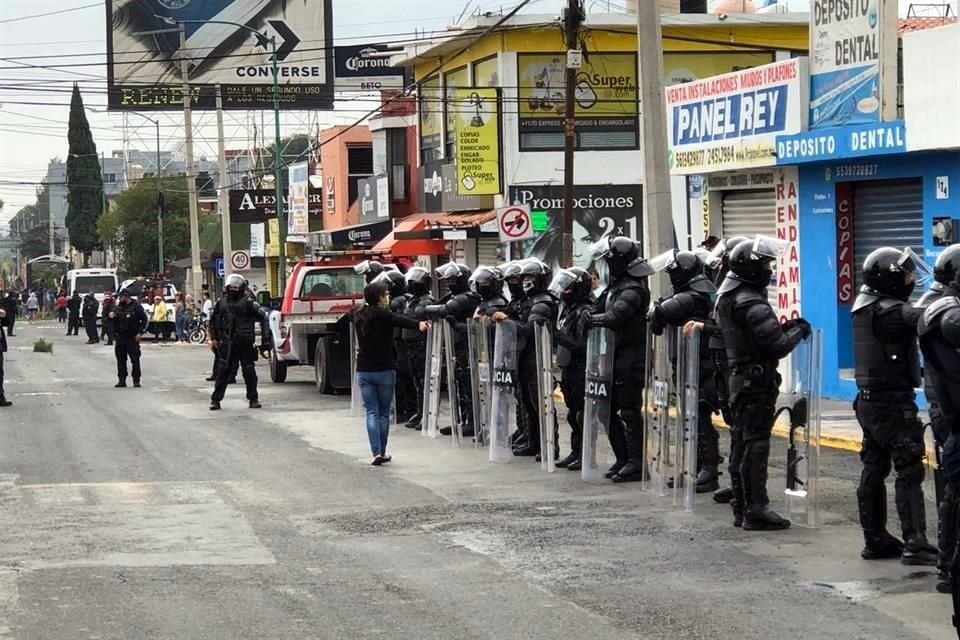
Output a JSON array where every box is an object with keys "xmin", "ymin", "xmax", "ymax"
[{"xmin": 458, "ymin": 87, "xmax": 500, "ymax": 195}]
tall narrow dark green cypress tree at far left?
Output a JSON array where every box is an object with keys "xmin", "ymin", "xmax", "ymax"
[{"xmin": 66, "ymin": 84, "xmax": 103, "ymax": 266}]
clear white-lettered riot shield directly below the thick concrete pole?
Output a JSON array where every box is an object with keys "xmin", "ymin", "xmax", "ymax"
[{"xmin": 641, "ymin": 329, "xmax": 677, "ymax": 496}]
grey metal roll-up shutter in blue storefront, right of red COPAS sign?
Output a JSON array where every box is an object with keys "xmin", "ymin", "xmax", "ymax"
[{"xmin": 853, "ymin": 179, "xmax": 923, "ymax": 296}]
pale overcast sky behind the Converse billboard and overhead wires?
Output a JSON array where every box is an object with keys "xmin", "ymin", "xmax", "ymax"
[{"xmin": 0, "ymin": 0, "xmax": 957, "ymax": 223}]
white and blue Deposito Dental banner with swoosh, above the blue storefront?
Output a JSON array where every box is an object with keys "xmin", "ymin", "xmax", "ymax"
[{"xmin": 810, "ymin": 0, "xmax": 897, "ymax": 129}]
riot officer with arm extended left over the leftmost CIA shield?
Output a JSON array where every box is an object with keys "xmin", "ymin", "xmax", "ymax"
[{"xmin": 491, "ymin": 258, "xmax": 558, "ymax": 456}]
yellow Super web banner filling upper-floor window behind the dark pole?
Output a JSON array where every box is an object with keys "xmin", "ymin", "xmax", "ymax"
[{"xmin": 517, "ymin": 53, "xmax": 639, "ymax": 134}]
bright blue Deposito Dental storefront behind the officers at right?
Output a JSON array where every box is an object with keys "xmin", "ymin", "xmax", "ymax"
[{"xmin": 777, "ymin": 121, "xmax": 960, "ymax": 400}]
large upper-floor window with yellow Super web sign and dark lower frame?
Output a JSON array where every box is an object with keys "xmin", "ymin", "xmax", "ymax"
[{"xmin": 517, "ymin": 52, "xmax": 640, "ymax": 151}]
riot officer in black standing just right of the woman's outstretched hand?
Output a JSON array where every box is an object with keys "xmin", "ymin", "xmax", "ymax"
[{"xmin": 427, "ymin": 262, "xmax": 480, "ymax": 437}]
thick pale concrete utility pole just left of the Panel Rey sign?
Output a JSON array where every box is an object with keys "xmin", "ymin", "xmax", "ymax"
[{"xmin": 637, "ymin": 2, "xmax": 673, "ymax": 297}]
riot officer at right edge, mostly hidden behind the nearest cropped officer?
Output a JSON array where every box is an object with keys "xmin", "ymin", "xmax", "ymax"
[{"xmin": 917, "ymin": 244, "xmax": 960, "ymax": 593}]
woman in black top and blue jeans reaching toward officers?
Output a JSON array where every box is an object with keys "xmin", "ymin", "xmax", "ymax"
[{"xmin": 354, "ymin": 280, "xmax": 430, "ymax": 466}]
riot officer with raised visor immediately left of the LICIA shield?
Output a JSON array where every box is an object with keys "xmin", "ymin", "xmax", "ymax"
[{"xmin": 550, "ymin": 267, "xmax": 596, "ymax": 471}]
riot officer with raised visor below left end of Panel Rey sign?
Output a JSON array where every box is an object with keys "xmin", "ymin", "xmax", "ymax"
[{"xmin": 649, "ymin": 251, "xmax": 720, "ymax": 493}]
